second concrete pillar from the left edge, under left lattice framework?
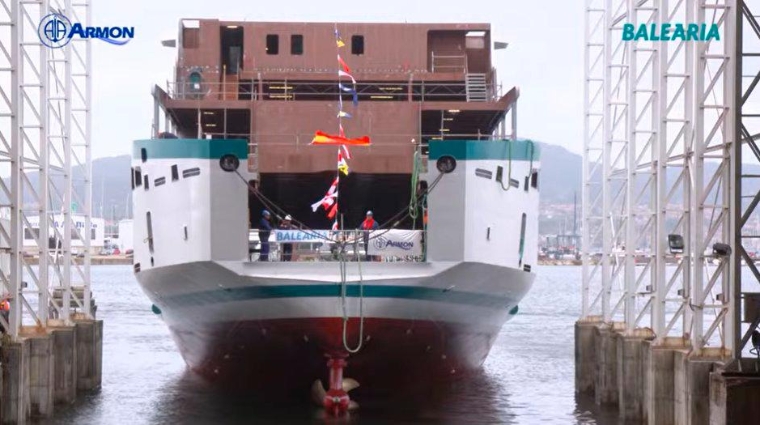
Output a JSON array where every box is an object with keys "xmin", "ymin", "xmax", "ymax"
[{"xmin": 28, "ymin": 334, "xmax": 53, "ymax": 418}]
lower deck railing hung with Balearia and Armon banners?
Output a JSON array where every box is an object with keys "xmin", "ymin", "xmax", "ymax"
[{"xmin": 248, "ymin": 229, "xmax": 425, "ymax": 262}]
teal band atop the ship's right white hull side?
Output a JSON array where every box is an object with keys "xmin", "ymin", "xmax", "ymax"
[{"xmin": 430, "ymin": 140, "xmax": 541, "ymax": 161}]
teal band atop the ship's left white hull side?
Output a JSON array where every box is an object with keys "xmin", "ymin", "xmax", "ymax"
[{"xmin": 132, "ymin": 139, "xmax": 248, "ymax": 162}]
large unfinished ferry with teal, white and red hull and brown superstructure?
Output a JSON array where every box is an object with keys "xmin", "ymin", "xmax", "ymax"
[{"xmin": 131, "ymin": 19, "xmax": 540, "ymax": 414}]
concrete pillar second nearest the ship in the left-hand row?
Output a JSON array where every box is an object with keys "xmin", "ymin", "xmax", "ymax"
[{"xmin": 50, "ymin": 326, "xmax": 77, "ymax": 404}]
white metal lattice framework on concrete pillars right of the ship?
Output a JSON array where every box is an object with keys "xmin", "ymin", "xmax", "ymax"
[{"xmin": 582, "ymin": 0, "xmax": 738, "ymax": 356}]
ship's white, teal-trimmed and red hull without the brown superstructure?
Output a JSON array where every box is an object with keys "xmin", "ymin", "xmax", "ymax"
[{"xmin": 133, "ymin": 140, "xmax": 538, "ymax": 389}]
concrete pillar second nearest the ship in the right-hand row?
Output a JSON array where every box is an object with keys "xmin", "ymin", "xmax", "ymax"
[{"xmin": 594, "ymin": 324, "xmax": 618, "ymax": 404}]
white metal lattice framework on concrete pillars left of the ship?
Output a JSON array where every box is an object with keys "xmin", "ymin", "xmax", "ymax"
[{"xmin": 0, "ymin": 0, "xmax": 92, "ymax": 337}]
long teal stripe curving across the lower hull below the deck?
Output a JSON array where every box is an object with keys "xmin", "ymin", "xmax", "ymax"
[{"xmin": 162, "ymin": 283, "xmax": 515, "ymax": 309}]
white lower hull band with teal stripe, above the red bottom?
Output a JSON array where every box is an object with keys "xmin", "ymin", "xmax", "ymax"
[{"xmin": 138, "ymin": 262, "xmax": 533, "ymax": 327}]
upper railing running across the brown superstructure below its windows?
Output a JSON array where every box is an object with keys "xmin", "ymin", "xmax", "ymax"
[{"xmin": 166, "ymin": 79, "xmax": 501, "ymax": 102}]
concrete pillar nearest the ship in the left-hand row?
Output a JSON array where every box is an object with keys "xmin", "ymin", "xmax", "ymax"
[{"xmin": 74, "ymin": 320, "xmax": 103, "ymax": 390}]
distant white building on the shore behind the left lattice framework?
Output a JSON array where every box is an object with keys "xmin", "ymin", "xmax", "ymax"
[{"xmin": 24, "ymin": 214, "xmax": 105, "ymax": 254}]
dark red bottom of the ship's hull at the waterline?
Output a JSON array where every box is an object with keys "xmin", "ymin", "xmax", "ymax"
[{"xmin": 171, "ymin": 318, "xmax": 499, "ymax": 396}]
